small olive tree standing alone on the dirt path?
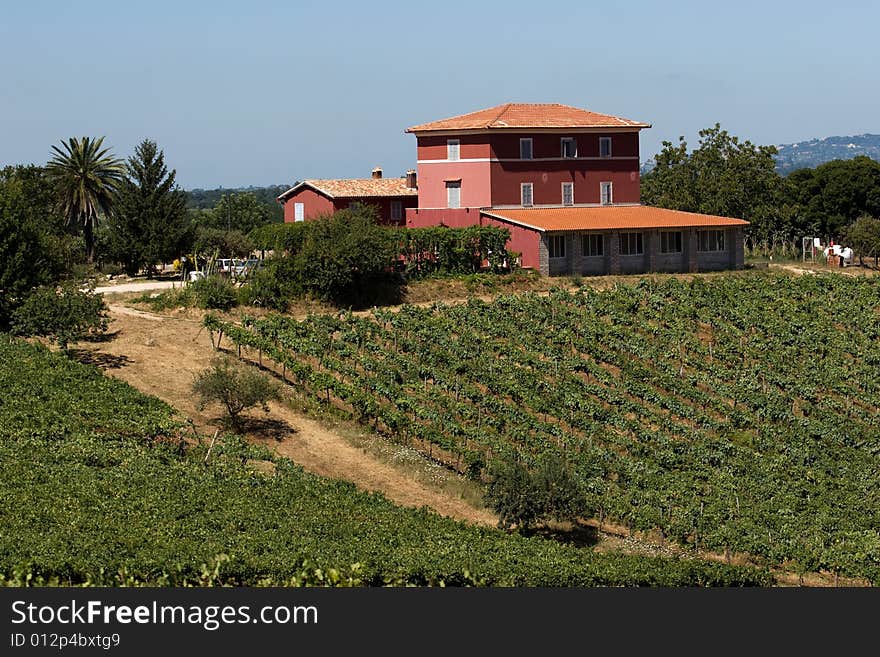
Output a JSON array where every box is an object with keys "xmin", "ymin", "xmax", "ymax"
[{"xmin": 192, "ymin": 356, "xmax": 281, "ymax": 430}]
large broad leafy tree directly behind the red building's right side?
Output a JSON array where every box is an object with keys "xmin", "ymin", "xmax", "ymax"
[{"xmin": 641, "ymin": 123, "xmax": 784, "ymax": 237}]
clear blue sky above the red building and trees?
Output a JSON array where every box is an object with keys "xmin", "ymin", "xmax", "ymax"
[{"xmin": 0, "ymin": 0, "xmax": 880, "ymax": 189}]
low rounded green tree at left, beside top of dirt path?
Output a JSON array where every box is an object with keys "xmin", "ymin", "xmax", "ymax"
[{"xmin": 12, "ymin": 282, "xmax": 109, "ymax": 351}]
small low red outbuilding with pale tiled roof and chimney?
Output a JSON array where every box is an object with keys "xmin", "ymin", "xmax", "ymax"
[{"xmin": 278, "ymin": 167, "xmax": 418, "ymax": 226}]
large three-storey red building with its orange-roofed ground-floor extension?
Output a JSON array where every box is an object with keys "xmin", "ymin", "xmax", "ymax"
[{"xmin": 406, "ymin": 103, "xmax": 748, "ymax": 274}]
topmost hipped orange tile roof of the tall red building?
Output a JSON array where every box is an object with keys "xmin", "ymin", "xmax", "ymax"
[{"xmin": 406, "ymin": 103, "xmax": 651, "ymax": 132}]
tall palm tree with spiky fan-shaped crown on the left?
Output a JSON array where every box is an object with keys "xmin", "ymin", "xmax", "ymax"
[{"xmin": 46, "ymin": 137, "xmax": 125, "ymax": 264}]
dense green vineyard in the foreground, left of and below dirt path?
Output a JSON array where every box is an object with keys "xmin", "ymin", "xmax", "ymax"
[{"xmin": 0, "ymin": 335, "xmax": 772, "ymax": 586}]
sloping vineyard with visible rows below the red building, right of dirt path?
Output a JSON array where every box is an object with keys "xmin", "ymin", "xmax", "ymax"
[{"xmin": 206, "ymin": 273, "xmax": 880, "ymax": 584}]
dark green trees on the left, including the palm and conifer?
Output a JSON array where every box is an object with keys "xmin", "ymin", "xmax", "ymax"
[{"xmin": 0, "ymin": 137, "xmax": 279, "ymax": 347}]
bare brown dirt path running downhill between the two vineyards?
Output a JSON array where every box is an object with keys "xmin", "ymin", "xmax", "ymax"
[{"xmin": 77, "ymin": 304, "xmax": 496, "ymax": 525}]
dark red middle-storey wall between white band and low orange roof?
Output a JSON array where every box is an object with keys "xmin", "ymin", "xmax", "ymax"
[{"xmin": 490, "ymin": 159, "xmax": 639, "ymax": 205}]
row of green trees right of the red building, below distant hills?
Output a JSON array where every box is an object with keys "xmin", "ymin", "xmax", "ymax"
[{"xmin": 641, "ymin": 123, "xmax": 880, "ymax": 257}]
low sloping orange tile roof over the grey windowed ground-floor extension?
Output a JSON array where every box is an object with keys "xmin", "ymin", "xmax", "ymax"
[{"xmin": 482, "ymin": 205, "xmax": 749, "ymax": 232}]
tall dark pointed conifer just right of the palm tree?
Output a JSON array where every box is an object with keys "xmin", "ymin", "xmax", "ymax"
[{"xmin": 109, "ymin": 139, "xmax": 190, "ymax": 275}]
